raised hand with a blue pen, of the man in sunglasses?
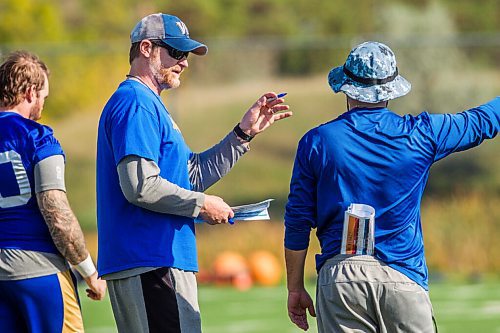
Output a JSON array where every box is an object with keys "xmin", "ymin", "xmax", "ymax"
[{"xmin": 240, "ymin": 92, "xmax": 292, "ymax": 136}]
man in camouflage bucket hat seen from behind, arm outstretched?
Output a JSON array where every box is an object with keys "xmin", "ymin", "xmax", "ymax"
[{"xmin": 285, "ymin": 42, "xmax": 500, "ymax": 332}]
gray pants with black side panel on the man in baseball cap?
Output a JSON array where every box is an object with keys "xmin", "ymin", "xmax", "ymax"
[{"xmin": 107, "ymin": 267, "xmax": 201, "ymax": 333}]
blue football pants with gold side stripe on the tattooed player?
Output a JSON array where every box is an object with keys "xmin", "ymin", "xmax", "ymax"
[{"xmin": 0, "ymin": 271, "xmax": 83, "ymax": 333}]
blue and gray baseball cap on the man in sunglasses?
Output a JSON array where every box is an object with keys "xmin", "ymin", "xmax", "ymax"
[{"xmin": 130, "ymin": 13, "xmax": 208, "ymax": 55}]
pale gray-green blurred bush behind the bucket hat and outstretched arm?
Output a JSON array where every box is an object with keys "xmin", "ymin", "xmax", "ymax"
[{"xmin": 379, "ymin": 2, "xmax": 496, "ymax": 113}]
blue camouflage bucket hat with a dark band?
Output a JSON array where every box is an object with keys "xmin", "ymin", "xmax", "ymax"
[{"xmin": 328, "ymin": 42, "xmax": 411, "ymax": 103}]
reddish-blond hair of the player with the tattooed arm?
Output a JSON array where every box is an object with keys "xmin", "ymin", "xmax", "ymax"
[{"xmin": 0, "ymin": 51, "xmax": 49, "ymax": 107}]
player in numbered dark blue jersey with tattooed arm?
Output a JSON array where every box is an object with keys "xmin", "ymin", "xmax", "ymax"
[{"xmin": 0, "ymin": 51, "xmax": 106, "ymax": 332}]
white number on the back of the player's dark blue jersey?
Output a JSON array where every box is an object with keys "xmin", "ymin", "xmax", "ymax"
[{"xmin": 0, "ymin": 150, "xmax": 31, "ymax": 208}]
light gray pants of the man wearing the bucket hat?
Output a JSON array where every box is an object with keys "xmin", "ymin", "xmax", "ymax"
[{"xmin": 316, "ymin": 255, "xmax": 436, "ymax": 333}]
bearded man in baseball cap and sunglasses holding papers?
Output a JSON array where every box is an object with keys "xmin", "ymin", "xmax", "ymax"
[{"xmin": 97, "ymin": 13, "xmax": 292, "ymax": 333}]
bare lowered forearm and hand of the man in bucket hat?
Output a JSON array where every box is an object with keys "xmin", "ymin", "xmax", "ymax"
[{"xmin": 285, "ymin": 248, "xmax": 316, "ymax": 331}]
